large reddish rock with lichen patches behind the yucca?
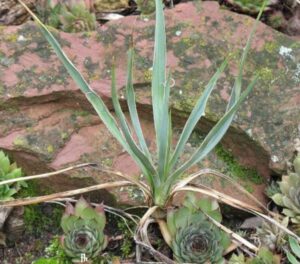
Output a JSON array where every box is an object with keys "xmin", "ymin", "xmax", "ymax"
[{"xmin": 0, "ymin": 2, "xmax": 300, "ymax": 204}]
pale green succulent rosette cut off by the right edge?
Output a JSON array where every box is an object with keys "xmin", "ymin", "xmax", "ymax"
[{"xmin": 272, "ymin": 154, "xmax": 300, "ymax": 225}]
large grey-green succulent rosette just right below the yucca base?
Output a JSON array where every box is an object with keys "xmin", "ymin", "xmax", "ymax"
[{"xmin": 167, "ymin": 194, "xmax": 230, "ymax": 263}]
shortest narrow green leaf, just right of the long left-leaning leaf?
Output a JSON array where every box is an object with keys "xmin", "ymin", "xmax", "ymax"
[{"xmin": 111, "ymin": 67, "xmax": 159, "ymax": 186}]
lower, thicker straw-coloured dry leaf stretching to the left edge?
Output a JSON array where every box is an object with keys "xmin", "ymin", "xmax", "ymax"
[{"xmin": 0, "ymin": 181, "xmax": 133, "ymax": 207}]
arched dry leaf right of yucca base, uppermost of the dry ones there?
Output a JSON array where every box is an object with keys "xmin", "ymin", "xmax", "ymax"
[{"xmin": 174, "ymin": 169, "xmax": 270, "ymax": 213}]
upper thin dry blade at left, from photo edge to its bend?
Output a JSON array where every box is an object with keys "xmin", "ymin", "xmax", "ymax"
[{"xmin": 0, "ymin": 163, "xmax": 96, "ymax": 186}]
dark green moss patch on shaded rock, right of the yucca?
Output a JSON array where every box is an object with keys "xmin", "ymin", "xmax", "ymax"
[{"xmin": 215, "ymin": 145, "xmax": 264, "ymax": 185}]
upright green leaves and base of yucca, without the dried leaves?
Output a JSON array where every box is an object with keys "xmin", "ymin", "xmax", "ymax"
[{"xmin": 19, "ymin": 0, "xmax": 258, "ymax": 208}]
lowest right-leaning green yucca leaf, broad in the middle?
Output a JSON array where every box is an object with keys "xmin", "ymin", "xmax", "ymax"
[{"xmin": 166, "ymin": 77, "xmax": 257, "ymax": 188}]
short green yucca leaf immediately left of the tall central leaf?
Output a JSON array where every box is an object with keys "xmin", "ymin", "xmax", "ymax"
[{"xmin": 126, "ymin": 47, "xmax": 151, "ymax": 160}]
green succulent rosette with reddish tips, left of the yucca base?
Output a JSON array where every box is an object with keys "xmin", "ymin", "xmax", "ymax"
[{"xmin": 61, "ymin": 198, "xmax": 107, "ymax": 262}]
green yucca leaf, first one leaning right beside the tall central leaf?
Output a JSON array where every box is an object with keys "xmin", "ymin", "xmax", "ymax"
[{"xmin": 170, "ymin": 60, "xmax": 227, "ymax": 169}]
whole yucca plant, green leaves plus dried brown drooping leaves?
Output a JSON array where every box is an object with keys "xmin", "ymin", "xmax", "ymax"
[{"xmin": 10, "ymin": 0, "xmax": 300, "ymax": 260}]
